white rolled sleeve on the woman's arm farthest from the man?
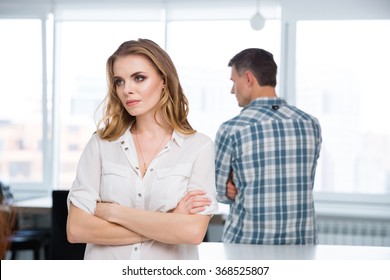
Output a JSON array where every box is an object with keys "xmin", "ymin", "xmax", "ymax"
[{"xmin": 68, "ymin": 134, "xmax": 101, "ymax": 214}]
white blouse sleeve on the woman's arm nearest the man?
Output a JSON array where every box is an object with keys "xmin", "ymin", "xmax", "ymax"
[{"xmin": 188, "ymin": 135, "xmax": 218, "ymax": 215}]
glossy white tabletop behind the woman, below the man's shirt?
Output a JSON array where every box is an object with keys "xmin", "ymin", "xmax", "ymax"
[{"xmin": 199, "ymin": 242, "xmax": 390, "ymax": 260}]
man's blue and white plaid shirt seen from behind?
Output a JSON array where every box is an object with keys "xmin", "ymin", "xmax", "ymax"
[{"xmin": 215, "ymin": 98, "xmax": 322, "ymax": 244}]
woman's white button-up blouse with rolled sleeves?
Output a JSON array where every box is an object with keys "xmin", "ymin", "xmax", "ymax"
[{"xmin": 68, "ymin": 130, "xmax": 218, "ymax": 260}]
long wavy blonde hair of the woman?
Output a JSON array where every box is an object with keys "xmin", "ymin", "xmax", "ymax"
[{"xmin": 97, "ymin": 39, "xmax": 195, "ymax": 141}]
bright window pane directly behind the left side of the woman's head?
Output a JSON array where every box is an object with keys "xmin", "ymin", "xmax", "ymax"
[{"xmin": 57, "ymin": 21, "xmax": 164, "ymax": 189}]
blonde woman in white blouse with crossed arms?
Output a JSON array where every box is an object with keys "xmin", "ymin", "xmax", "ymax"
[{"xmin": 67, "ymin": 39, "xmax": 218, "ymax": 259}]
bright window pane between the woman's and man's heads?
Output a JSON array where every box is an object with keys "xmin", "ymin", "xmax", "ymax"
[{"xmin": 167, "ymin": 20, "xmax": 281, "ymax": 139}]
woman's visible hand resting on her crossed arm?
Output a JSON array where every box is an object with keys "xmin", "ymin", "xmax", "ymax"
[{"xmin": 171, "ymin": 190, "xmax": 211, "ymax": 214}]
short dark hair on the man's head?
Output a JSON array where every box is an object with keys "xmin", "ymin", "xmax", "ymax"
[{"xmin": 228, "ymin": 48, "xmax": 278, "ymax": 87}]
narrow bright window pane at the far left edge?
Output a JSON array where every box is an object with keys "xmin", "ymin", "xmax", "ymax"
[{"xmin": 0, "ymin": 20, "xmax": 43, "ymax": 185}]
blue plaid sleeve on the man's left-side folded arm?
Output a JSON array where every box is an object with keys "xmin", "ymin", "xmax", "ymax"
[{"xmin": 215, "ymin": 125, "xmax": 233, "ymax": 204}]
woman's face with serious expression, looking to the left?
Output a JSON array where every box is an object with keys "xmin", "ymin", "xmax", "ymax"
[{"xmin": 113, "ymin": 55, "xmax": 164, "ymax": 116}]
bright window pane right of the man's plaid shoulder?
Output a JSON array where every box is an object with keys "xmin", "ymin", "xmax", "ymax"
[{"xmin": 296, "ymin": 20, "xmax": 390, "ymax": 194}]
